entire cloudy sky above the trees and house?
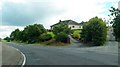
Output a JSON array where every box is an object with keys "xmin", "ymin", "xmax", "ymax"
[{"xmin": 0, "ymin": 0, "xmax": 119, "ymax": 38}]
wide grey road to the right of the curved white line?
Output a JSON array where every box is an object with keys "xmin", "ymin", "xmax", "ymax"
[{"xmin": 2, "ymin": 43, "xmax": 118, "ymax": 65}]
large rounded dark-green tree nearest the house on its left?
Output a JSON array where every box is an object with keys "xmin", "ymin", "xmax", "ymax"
[{"xmin": 23, "ymin": 24, "xmax": 46, "ymax": 43}]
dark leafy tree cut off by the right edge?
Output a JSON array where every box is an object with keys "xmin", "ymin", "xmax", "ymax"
[{"xmin": 109, "ymin": 7, "xmax": 120, "ymax": 41}]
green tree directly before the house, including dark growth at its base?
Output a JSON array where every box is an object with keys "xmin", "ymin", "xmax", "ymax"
[{"xmin": 53, "ymin": 23, "xmax": 71, "ymax": 43}]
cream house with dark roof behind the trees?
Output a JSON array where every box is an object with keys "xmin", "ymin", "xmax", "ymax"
[{"xmin": 51, "ymin": 20, "xmax": 84, "ymax": 30}]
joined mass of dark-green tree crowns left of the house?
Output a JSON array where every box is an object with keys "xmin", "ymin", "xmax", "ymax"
[{"xmin": 10, "ymin": 24, "xmax": 46, "ymax": 43}]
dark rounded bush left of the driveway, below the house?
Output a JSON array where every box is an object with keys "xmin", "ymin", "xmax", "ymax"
[{"xmin": 55, "ymin": 32, "xmax": 68, "ymax": 43}]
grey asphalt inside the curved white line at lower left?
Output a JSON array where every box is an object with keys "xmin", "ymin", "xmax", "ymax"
[{"xmin": 0, "ymin": 43, "xmax": 24, "ymax": 65}]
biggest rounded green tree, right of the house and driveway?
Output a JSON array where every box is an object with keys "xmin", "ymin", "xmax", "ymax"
[{"xmin": 81, "ymin": 17, "xmax": 107, "ymax": 46}]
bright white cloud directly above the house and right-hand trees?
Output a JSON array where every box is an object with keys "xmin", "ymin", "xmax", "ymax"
[{"xmin": 38, "ymin": 0, "xmax": 117, "ymax": 28}]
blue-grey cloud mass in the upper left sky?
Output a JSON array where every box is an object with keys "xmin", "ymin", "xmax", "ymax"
[{"xmin": 2, "ymin": 1, "xmax": 62, "ymax": 26}]
